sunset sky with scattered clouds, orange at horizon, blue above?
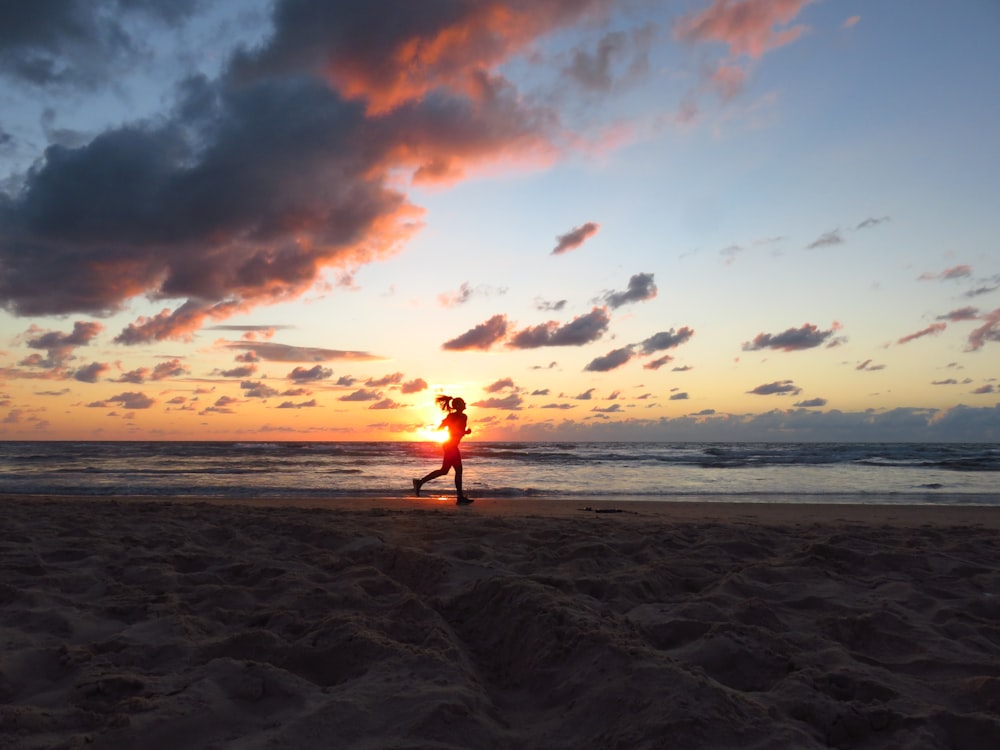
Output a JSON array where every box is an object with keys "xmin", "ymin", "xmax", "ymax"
[{"xmin": 0, "ymin": 0, "xmax": 1000, "ymax": 442}]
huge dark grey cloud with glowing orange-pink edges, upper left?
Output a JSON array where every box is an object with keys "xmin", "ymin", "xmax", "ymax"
[{"xmin": 0, "ymin": 0, "xmax": 608, "ymax": 344}]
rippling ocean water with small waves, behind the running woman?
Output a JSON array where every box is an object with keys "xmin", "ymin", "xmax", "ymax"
[{"xmin": 0, "ymin": 441, "xmax": 1000, "ymax": 505}]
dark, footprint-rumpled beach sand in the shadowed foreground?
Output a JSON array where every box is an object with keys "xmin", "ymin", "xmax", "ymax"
[{"xmin": 0, "ymin": 496, "xmax": 1000, "ymax": 750}]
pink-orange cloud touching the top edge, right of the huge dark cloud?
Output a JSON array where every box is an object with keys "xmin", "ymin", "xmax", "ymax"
[{"xmin": 674, "ymin": 0, "xmax": 811, "ymax": 58}]
